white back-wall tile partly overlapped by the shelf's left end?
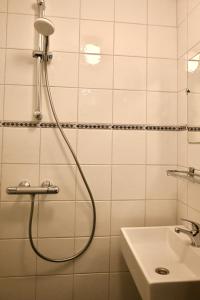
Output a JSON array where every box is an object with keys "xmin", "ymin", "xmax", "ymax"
[{"xmin": 146, "ymin": 166, "xmax": 177, "ymax": 200}]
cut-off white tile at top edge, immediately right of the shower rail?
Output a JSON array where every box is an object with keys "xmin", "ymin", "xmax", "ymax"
[{"xmin": 46, "ymin": 0, "xmax": 80, "ymax": 18}]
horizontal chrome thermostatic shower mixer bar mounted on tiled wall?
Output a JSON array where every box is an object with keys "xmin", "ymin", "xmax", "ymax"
[{"xmin": 6, "ymin": 181, "xmax": 59, "ymax": 195}]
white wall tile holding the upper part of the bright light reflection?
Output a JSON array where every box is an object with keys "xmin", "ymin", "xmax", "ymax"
[{"xmin": 80, "ymin": 20, "xmax": 113, "ymax": 54}]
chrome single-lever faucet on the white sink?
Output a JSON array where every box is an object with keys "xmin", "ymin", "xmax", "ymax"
[{"xmin": 175, "ymin": 218, "xmax": 200, "ymax": 247}]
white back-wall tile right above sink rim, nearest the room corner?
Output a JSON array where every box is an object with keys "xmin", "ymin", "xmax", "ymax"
[{"xmin": 146, "ymin": 200, "xmax": 176, "ymax": 226}]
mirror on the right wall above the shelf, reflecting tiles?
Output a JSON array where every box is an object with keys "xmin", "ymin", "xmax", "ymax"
[{"xmin": 186, "ymin": 45, "xmax": 200, "ymax": 143}]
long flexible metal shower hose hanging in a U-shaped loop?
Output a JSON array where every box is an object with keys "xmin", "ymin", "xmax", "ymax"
[{"xmin": 28, "ymin": 60, "xmax": 96, "ymax": 263}]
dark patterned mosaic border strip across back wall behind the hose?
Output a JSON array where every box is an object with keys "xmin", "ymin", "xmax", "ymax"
[{"xmin": 0, "ymin": 121, "xmax": 191, "ymax": 131}]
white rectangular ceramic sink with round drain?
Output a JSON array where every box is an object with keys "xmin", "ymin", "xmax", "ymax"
[{"xmin": 121, "ymin": 226, "xmax": 200, "ymax": 300}]
